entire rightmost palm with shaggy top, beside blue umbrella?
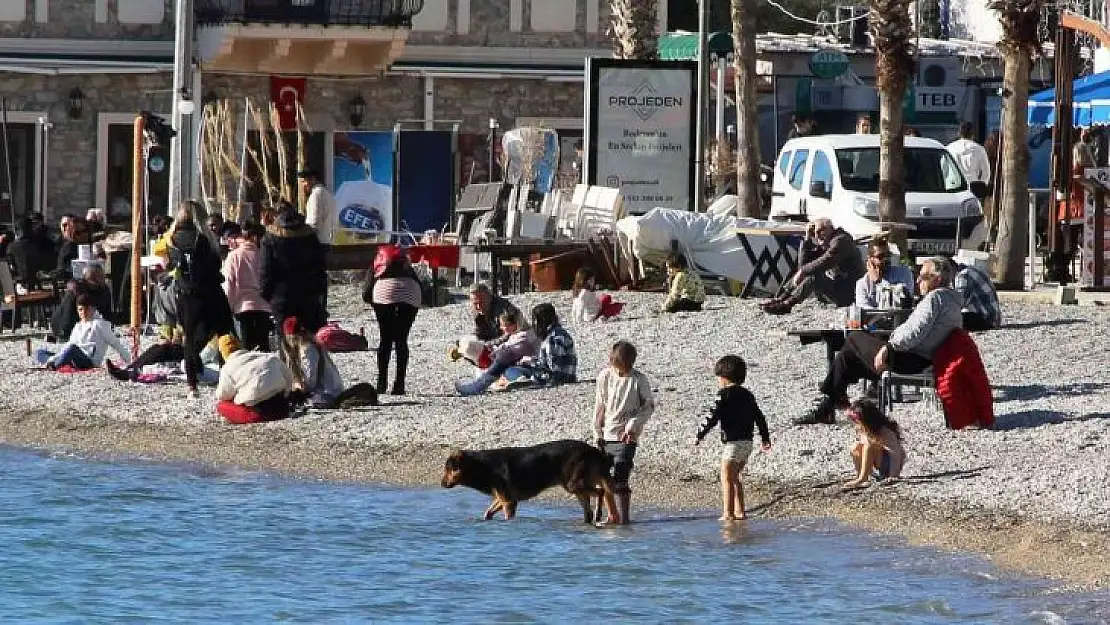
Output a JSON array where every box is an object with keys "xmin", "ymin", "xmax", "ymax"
[{"xmin": 987, "ymin": 0, "xmax": 1043, "ymax": 289}]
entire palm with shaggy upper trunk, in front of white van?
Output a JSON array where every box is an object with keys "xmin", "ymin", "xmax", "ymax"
[{"xmin": 868, "ymin": 0, "xmax": 914, "ymax": 243}]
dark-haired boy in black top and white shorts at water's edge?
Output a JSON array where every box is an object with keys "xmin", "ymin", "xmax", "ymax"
[{"xmin": 694, "ymin": 355, "xmax": 770, "ymax": 521}]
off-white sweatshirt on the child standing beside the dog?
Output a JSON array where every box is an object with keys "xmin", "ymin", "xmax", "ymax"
[{"xmin": 594, "ymin": 366, "xmax": 655, "ymax": 442}]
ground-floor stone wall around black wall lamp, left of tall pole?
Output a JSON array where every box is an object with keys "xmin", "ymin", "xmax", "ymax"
[{"xmin": 0, "ymin": 73, "xmax": 171, "ymax": 219}]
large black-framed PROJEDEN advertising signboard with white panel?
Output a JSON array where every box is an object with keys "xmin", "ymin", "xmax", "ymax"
[{"xmin": 585, "ymin": 58, "xmax": 697, "ymax": 214}]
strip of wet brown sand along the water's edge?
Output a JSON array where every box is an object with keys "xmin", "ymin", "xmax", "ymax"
[{"xmin": 0, "ymin": 409, "xmax": 1110, "ymax": 591}]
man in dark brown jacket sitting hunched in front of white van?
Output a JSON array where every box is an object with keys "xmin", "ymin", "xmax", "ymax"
[{"xmin": 759, "ymin": 218, "xmax": 866, "ymax": 314}]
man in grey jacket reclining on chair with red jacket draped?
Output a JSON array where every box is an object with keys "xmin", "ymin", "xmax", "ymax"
[{"xmin": 794, "ymin": 259, "xmax": 963, "ymax": 425}]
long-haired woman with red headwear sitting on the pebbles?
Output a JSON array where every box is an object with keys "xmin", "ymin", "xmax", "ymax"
[{"xmin": 281, "ymin": 316, "xmax": 377, "ymax": 410}]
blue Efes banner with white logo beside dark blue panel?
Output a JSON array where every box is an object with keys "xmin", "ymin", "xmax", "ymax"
[{"xmin": 335, "ymin": 132, "xmax": 393, "ymax": 245}]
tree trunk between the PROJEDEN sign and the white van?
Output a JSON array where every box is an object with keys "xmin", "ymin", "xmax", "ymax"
[{"xmin": 733, "ymin": 0, "xmax": 763, "ymax": 218}]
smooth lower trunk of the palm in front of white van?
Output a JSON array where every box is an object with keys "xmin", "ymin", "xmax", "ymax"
[{"xmin": 879, "ymin": 87, "xmax": 907, "ymax": 247}]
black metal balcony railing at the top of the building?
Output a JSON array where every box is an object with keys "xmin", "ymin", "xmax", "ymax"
[{"xmin": 194, "ymin": 0, "xmax": 424, "ymax": 28}]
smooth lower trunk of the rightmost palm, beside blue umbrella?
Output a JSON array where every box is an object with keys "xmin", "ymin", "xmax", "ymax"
[{"xmin": 995, "ymin": 49, "xmax": 1032, "ymax": 290}]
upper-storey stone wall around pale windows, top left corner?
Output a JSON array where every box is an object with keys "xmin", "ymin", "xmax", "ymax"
[{"xmin": 0, "ymin": 0, "xmax": 174, "ymax": 40}]
